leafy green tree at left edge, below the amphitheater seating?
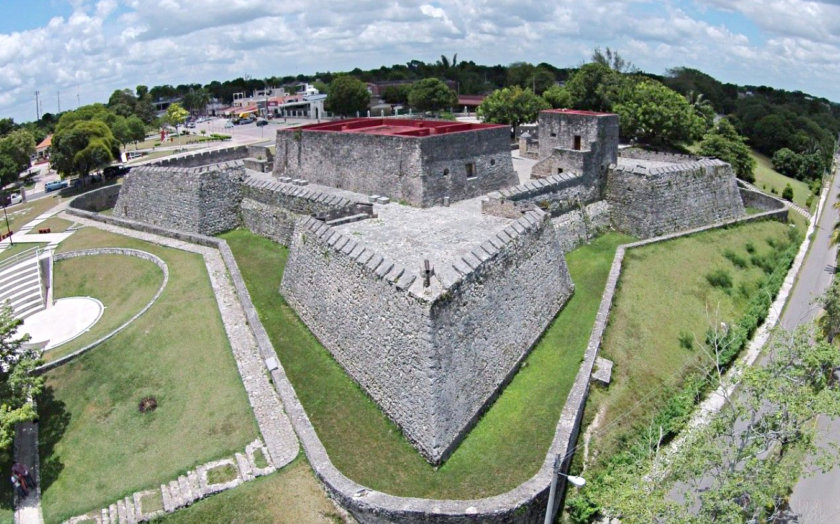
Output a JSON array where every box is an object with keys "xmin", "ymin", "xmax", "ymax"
[{"xmin": 0, "ymin": 306, "xmax": 44, "ymax": 459}]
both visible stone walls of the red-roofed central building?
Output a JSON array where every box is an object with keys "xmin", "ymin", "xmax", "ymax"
[{"xmin": 274, "ymin": 128, "xmax": 517, "ymax": 207}]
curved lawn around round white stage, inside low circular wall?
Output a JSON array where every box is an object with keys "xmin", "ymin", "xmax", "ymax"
[{"xmin": 44, "ymin": 255, "xmax": 163, "ymax": 362}]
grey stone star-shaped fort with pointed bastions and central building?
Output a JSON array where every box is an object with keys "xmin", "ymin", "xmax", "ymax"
[{"xmin": 114, "ymin": 110, "xmax": 745, "ymax": 464}]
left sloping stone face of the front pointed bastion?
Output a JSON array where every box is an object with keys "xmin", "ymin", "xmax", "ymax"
[{"xmin": 281, "ymin": 218, "xmax": 436, "ymax": 458}]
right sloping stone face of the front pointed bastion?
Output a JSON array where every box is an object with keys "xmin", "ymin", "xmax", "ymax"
[{"xmin": 431, "ymin": 210, "xmax": 574, "ymax": 458}]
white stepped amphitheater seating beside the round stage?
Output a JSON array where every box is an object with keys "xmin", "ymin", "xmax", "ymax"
[{"xmin": 0, "ymin": 248, "xmax": 45, "ymax": 318}]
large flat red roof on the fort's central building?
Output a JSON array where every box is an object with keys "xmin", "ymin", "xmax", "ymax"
[{"xmin": 292, "ymin": 118, "xmax": 508, "ymax": 137}]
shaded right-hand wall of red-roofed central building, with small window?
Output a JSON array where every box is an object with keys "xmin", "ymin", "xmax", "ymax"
[{"xmin": 420, "ymin": 128, "xmax": 519, "ymax": 207}]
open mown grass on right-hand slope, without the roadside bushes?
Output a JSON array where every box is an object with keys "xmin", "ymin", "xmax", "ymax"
[{"xmin": 587, "ymin": 221, "xmax": 790, "ymax": 467}]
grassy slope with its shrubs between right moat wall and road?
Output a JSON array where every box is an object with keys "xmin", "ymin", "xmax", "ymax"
[{"xmin": 568, "ymin": 222, "xmax": 802, "ymax": 521}]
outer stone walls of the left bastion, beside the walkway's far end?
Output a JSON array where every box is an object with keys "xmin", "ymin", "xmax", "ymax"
[{"xmin": 114, "ymin": 162, "xmax": 244, "ymax": 235}]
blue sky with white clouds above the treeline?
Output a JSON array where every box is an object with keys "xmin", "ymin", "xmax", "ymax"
[{"xmin": 0, "ymin": 0, "xmax": 840, "ymax": 122}]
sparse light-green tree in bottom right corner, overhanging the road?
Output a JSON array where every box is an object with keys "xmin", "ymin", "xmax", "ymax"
[{"xmin": 591, "ymin": 326, "xmax": 840, "ymax": 523}]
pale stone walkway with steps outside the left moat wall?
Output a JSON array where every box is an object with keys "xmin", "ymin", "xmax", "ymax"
[{"xmin": 15, "ymin": 213, "xmax": 299, "ymax": 524}]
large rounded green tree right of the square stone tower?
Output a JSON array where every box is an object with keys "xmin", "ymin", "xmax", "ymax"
[{"xmin": 613, "ymin": 80, "xmax": 704, "ymax": 146}]
